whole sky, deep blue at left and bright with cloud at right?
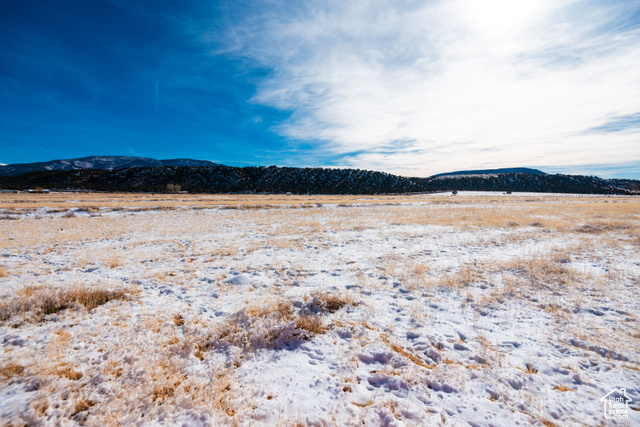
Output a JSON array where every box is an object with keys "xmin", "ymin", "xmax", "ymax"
[{"xmin": 0, "ymin": 0, "xmax": 640, "ymax": 179}]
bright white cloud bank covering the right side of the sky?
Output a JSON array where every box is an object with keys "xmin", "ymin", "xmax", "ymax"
[{"xmin": 221, "ymin": 0, "xmax": 640, "ymax": 175}]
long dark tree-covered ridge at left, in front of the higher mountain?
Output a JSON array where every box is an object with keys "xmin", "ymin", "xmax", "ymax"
[{"xmin": 0, "ymin": 166, "xmax": 425, "ymax": 194}]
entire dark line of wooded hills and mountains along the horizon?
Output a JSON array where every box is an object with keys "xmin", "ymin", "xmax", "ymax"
[{"xmin": 0, "ymin": 156, "xmax": 640, "ymax": 194}]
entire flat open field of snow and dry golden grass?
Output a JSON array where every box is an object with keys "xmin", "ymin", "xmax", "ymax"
[{"xmin": 0, "ymin": 193, "xmax": 640, "ymax": 426}]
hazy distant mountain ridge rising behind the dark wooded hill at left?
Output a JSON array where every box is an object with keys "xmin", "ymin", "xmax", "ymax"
[{"xmin": 0, "ymin": 156, "xmax": 219, "ymax": 176}]
